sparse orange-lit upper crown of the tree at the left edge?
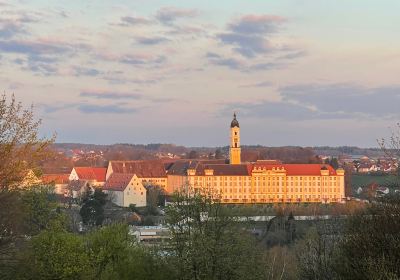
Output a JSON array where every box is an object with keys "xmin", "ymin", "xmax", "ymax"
[{"xmin": 0, "ymin": 94, "xmax": 54, "ymax": 188}]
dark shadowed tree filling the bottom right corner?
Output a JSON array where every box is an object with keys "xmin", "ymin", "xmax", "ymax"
[{"xmin": 337, "ymin": 195, "xmax": 400, "ymax": 279}]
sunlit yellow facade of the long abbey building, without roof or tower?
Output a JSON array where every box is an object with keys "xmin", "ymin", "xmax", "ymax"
[{"xmin": 187, "ymin": 167, "xmax": 345, "ymax": 203}]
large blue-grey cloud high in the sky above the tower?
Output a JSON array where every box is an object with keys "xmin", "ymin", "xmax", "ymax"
[{"xmin": 217, "ymin": 15, "xmax": 285, "ymax": 58}]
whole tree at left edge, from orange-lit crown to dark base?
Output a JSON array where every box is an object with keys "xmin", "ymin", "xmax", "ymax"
[{"xmin": 0, "ymin": 94, "xmax": 54, "ymax": 268}]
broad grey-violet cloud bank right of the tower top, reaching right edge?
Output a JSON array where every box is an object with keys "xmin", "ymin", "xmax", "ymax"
[{"xmin": 227, "ymin": 84, "xmax": 400, "ymax": 121}]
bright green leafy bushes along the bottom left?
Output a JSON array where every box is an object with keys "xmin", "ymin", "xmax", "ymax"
[{"xmin": 16, "ymin": 224, "xmax": 175, "ymax": 280}]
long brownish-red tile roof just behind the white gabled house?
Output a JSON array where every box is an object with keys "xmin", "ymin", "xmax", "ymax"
[{"xmin": 111, "ymin": 160, "xmax": 167, "ymax": 178}]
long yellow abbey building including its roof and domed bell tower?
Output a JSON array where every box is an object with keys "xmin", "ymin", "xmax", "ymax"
[{"xmin": 168, "ymin": 114, "xmax": 345, "ymax": 203}]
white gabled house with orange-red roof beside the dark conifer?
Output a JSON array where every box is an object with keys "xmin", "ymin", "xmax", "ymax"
[{"xmin": 103, "ymin": 173, "xmax": 146, "ymax": 207}]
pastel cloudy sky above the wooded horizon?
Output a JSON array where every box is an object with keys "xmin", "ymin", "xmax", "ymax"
[{"xmin": 0, "ymin": 0, "xmax": 400, "ymax": 147}]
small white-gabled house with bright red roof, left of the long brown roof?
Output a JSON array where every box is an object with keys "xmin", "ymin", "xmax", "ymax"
[{"xmin": 69, "ymin": 167, "xmax": 107, "ymax": 187}]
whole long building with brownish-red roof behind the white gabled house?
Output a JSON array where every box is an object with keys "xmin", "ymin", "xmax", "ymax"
[{"xmin": 106, "ymin": 160, "xmax": 167, "ymax": 189}]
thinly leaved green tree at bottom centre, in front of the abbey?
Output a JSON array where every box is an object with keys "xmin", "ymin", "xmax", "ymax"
[{"xmin": 166, "ymin": 188, "xmax": 266, "ymax": 280}]
